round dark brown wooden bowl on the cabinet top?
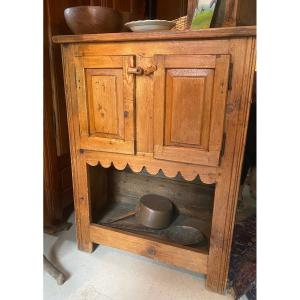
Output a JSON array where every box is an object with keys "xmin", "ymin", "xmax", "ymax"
[{"xmin": 64, "ymin": 6, "xmax": 123, "ymax": 34}]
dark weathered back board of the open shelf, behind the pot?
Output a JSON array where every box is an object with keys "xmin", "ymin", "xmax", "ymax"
[{"xmin": 104, "ymin": 169, "xmax": 214, "ymax": 215}]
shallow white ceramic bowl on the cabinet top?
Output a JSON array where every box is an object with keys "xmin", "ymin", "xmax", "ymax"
[{"xmin": 125, "ymin": 20, "xmax": 176, "ymax": 32}]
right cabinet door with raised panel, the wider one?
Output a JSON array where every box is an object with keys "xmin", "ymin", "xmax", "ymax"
[{"xmin": 154, "ymin": 55, "xmax": 230, "ymax": 166}]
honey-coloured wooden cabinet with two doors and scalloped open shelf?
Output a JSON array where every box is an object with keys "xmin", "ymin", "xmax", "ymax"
[{"xmin": 53, "ymin": 26, "xmax": 256, "ymax": 293}]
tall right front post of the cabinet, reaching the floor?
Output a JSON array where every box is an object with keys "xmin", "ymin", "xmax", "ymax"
[{"xmin": 206, "ymin": 38, "xmax": 255, "ymax": 293}]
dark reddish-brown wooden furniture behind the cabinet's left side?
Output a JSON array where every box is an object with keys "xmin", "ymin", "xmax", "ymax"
[{"xmin": 44, "ymin": 0, "xmax": 89, "ymax": 227}]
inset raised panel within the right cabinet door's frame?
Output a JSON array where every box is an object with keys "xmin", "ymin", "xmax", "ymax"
[{"xmin": 165, "ymin": 69, "xmax": 214, "ymax": 150}]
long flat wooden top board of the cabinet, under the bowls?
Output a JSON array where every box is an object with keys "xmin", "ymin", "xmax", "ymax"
[{"xmin": 52, "ymin": 26, "xmax": 256, "ymax": 43}]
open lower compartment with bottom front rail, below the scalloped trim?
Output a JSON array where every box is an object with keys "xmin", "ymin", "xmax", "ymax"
[{"xmin": 90, "ymin": 166, "xmax": 214, "ymax": 274}]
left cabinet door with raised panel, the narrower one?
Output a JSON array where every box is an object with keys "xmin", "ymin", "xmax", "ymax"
[{"xmin": 75, "ymin": 55, "xmax": 135, "ymax": 154}]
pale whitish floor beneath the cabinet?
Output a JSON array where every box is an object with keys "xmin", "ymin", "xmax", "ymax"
[{"xmin": 44, "ymin": 182, "xmax": 255, "ymax": 300}]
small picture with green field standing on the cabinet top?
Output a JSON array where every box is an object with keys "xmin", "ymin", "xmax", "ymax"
[{"xmin": 190, "ymin": 0, "xmax": 220, "ymax": 30}]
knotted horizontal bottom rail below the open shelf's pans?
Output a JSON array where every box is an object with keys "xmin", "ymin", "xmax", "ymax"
[{"xmin": 89, "ymin": 224, "xmax": 208, "ymax": 274}]
